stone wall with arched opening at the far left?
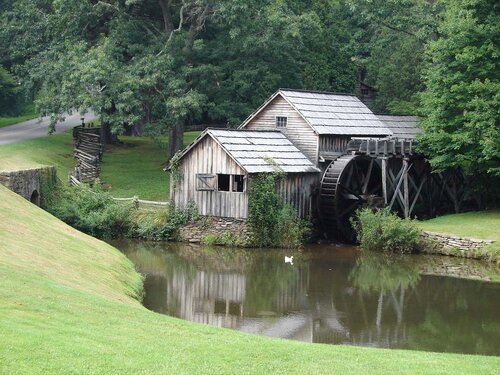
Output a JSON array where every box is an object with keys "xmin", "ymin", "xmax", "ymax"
[{"xmin": 0, "ymin": 167, "xmax": 56, "ymax": 206}]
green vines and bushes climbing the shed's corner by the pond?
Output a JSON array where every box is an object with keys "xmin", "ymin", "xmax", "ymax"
[{"xmin": 248, "ymin": 173, "xmax": 309, "ymax": 248}]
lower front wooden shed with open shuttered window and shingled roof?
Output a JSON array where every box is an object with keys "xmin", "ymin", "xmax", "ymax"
[{"xmin": 170, "ymin": 129, "xmax": 320, "ymax": 219}]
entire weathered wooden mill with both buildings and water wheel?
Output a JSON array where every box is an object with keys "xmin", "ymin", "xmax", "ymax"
[{"xmin": 171, "ymin": 89, "xmax": 461, "ymax": 241}]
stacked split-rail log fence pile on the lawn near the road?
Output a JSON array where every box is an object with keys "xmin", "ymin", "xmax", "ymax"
[{"xmin": 69, "ymin": 125, "xmax": 103, "ymax": 185}]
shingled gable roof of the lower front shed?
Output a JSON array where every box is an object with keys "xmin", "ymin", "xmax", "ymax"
[{"xmin": 172, "ymin": 128, "xmax": 320, "ymax": 173}]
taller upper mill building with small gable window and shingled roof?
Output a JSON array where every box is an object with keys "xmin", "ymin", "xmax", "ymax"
[{"xmin": 240, "ymin": 89, "xmax": 393, "ymax": 165}]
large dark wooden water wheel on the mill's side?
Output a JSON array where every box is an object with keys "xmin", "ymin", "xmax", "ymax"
[{"xmin": 320, "ymin": 155, "xmax": 382, "ymax": 242}]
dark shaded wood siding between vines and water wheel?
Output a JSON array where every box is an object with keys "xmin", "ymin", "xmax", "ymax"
[{"xmin": 278, "ymin": 173, "xmax": 320, "ymax": 218}]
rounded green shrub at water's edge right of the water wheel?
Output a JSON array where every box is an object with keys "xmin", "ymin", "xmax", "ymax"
[{"xmin": 351, "ymin": 208, "xmax": 422, "ymax": 253}]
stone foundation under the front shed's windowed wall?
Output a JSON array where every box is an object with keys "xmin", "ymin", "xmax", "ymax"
[{"xmin": 179, "ymin": 216, "xmax": 251, "ymax": 247}]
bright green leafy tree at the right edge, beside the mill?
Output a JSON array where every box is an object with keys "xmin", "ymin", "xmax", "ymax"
[{"xmin": 420, "ymin": 0, "xmax": 500, "ymax": 178}]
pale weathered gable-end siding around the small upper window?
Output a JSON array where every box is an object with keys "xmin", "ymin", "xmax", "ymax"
[{"xmin": 245, "ymin": 96, "xmax": 318, "ymax": 165}]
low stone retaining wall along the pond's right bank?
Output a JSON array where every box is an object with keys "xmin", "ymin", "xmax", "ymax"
[{"xmin": 423, "ymin": 232, "xmax": 495, "ymax": 259}]
